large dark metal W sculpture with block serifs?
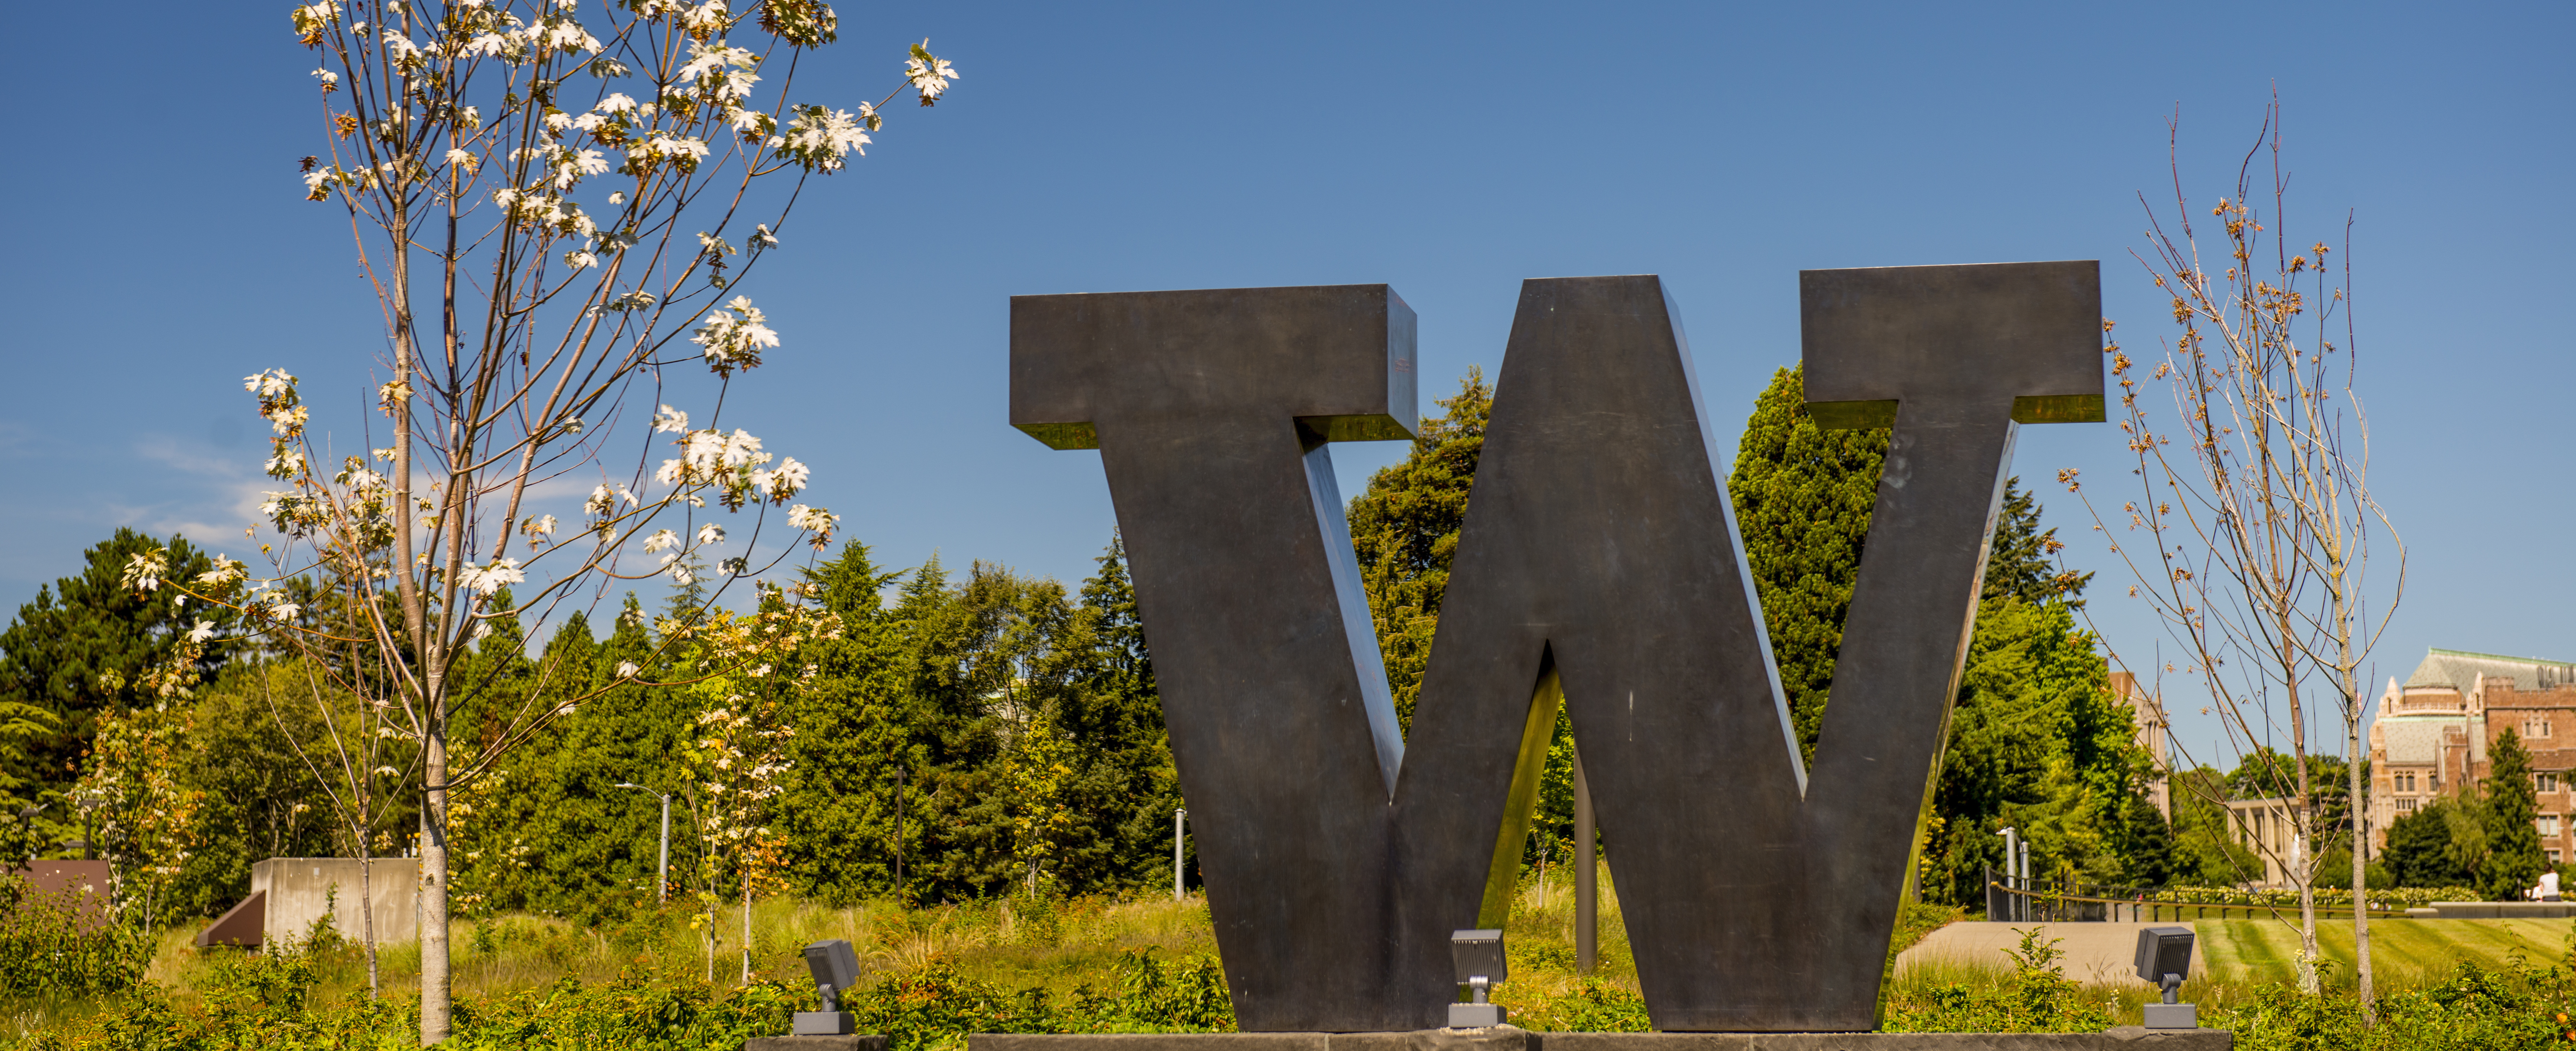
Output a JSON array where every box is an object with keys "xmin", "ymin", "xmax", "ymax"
[{"xmin": 1010, "ymin": 263, "xmax": 2102, "ymax": 1033}]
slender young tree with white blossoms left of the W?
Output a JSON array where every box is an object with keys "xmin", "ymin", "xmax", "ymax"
[{"xmin": 113, "ymin": 0, "xmax": 958, "ymax": 1043}]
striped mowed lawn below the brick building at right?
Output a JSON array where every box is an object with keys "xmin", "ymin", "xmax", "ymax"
[{"xmin": 2192, "ymin": 915, "xmax": 2571, "ymax": 989}]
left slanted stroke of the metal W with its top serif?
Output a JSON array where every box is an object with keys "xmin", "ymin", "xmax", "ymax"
[{"xmin": 1010, "ymin": 286, "xmax": 1432, "ymax": 1030}]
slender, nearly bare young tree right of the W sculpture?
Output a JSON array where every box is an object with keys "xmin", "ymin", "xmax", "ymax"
[{"xmin": 2058, "ymin": 100, "xmax": 2406, "ymax": 1005}]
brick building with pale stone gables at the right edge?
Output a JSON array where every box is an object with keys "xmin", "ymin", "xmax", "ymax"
[{"xmin": 2365, "ymin": 649, "xmax": 2576, "ymax": 863}]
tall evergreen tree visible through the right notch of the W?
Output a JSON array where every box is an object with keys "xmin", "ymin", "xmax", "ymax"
[{"xmin": 1726, "ymin": 368, "xmax": 1888, "ymax": 762}]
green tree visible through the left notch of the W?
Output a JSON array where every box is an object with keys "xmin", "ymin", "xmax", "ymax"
[{"xmin": 1350, "ymin": 368, "xmax": 1494, "ymax": 729}]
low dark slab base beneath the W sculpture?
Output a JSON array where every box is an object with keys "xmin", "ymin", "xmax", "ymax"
[{"xmin": 968, "ymin": 1025, "xmax": 2233, "ymax": 1051}]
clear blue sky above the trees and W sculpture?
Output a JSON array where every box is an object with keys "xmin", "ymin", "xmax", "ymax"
[{"xmin": 0, "ymin": 3, "xmax": 2576, "ymax": 773}]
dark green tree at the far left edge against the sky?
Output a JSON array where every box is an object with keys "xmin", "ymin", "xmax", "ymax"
[{"xmin": 0, "ymin": 528, "xmax": 237, "ymax": 809}]
